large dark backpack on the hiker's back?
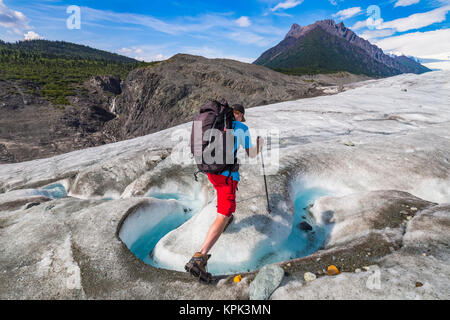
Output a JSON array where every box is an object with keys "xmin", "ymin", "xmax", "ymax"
[{"xmin": 191, "ymin": 100, "xmax": 239, "ymax": 181}]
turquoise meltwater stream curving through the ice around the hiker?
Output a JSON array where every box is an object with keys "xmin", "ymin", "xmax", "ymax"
[{"xmin": 120, "ymin": 184, "xmax": 329, "ymax": 275}]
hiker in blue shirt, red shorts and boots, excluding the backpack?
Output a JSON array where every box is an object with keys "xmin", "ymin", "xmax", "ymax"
[{"xmin": 185, "ymin": 104, "xmax": 264, "ymax": 282}]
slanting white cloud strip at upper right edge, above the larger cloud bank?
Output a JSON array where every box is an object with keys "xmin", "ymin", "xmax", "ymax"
[{"xmin": 380, "ymin": 5, "xmax": 450, "ymax": 32}]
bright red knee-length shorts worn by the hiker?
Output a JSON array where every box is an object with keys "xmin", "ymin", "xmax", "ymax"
[{"xmin": 208, "ymin": 173, "xmax": 238, "ymax": 217}]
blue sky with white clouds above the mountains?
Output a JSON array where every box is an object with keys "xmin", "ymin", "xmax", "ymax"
[{"xmin": 0, "ymin": 0, "xmax": 450, "ymax": 68}]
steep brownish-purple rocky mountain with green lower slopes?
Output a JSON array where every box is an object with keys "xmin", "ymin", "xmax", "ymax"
[{"xmin": 254, "ymin": 19, "xmax": 428, "ymax": 76}]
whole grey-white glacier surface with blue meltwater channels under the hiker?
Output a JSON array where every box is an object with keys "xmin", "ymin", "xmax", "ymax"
[{"xmin": 0, "ymin": 71, "xmax": 450, "ymax": 300}]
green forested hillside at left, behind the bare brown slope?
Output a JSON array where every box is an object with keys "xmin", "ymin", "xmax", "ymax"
[{"xmin": 0, "ymin": 40, "xmax": 151, "ymax": 105}]
